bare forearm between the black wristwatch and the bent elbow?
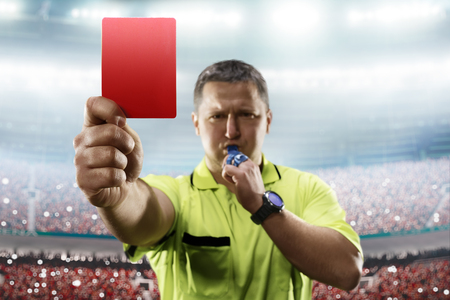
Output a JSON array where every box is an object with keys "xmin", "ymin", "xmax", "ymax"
[{"xmin": 262, "ymin": 210, "xmax": 362, "ymax": 290}]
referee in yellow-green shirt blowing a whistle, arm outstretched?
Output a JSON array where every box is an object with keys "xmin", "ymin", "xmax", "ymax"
[{"xmin": 74, "ymin": 60, "xmax": 362, "ymax": 300}]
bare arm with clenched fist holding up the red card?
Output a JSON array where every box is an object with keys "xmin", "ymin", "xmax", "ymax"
[{"xmin": 73, "ymin": 97, "xmax": 174, "ymax": 246}]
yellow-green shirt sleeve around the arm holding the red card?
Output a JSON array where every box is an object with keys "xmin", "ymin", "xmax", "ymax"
[{"xmin": 123, "ymin": 174, "xmax": 180, "ymax": 262}]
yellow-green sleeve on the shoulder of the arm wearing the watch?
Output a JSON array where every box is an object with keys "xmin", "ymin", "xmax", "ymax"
[{"xmin": 300, "ymin": 173, "xmax": 363, "ymax": 256}]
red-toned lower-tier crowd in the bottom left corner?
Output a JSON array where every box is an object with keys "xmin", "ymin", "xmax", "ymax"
[{"xmin": 0, "ymin": 253, "xmax": 159, "ymax": 300}]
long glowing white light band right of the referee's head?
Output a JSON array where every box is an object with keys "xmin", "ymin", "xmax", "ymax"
[{"xmin": 261, "ymin": 59, "xmax": 450, "ymax": 91}]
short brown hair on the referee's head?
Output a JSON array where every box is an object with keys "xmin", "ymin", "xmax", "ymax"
[{"xmin": 194, "ymin": 59, "xmax": 269, "ymax": 111}]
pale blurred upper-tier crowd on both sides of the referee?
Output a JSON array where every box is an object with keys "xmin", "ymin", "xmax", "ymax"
[{"xmin": 0, "ymin": 157, "xmax": 450, "ymax": 235}]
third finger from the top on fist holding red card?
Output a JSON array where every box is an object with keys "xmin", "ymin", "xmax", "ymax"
[{"xmin": 75, "ymin": 146, "xmax": 128, "ymax": 170}]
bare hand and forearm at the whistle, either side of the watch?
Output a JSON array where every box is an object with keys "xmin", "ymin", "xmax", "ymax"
[{"xmin": 222, "ymin": 160, "xmax": 363, "ymax": 290}]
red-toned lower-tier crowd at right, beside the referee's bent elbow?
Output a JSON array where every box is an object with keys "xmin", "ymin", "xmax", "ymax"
[{"xmin": 313, "ymin": 249, "xmax": 450, "ymax": 300}]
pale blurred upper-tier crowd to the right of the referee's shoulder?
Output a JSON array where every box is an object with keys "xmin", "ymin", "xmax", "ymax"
[{"xmin": 314, "ymin": 157, "xmax": 450, "ymax": 235}]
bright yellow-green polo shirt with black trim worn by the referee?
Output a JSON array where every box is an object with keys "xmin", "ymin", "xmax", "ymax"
[{"xmin": 124, "ymin": 156, "xmax": 362, "ymax": 300}]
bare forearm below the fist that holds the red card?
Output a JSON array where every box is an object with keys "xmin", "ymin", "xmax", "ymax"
[{"xmin": 97, "ymin": 179, "xmax": 170, "ymax": 245}]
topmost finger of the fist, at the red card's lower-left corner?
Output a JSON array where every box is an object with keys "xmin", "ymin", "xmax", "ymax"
[{"xmin": 84, "ymin": 97, "xmax": 126, "ymax": 127}]
